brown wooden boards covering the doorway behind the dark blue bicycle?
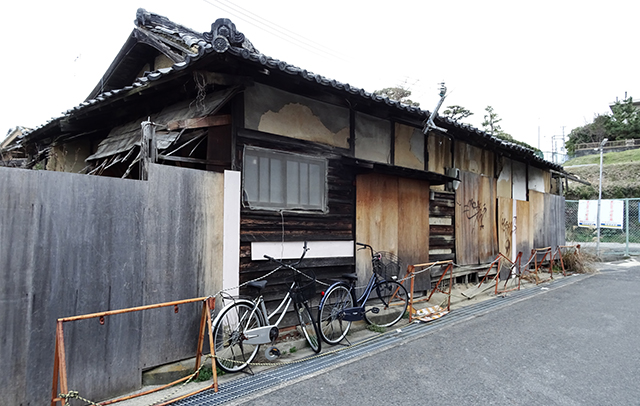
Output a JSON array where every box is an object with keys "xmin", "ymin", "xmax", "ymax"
[{"xmin": 356, "ymin": 174, "xmax": 430, "ymax": 290}]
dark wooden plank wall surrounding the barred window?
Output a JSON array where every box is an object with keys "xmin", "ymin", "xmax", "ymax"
[{"xmin": 237, "ymin": 130, "xmax": 355, "ymax": 308}]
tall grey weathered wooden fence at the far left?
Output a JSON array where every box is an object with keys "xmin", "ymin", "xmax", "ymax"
[{"xmin": 0, "ymin": 165, "xmax": 222, "ymax": 405}]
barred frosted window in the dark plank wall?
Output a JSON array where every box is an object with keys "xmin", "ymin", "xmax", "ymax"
[{"xmin": 243, "ymin": 147, "xmax": 327, "ymax": 211}]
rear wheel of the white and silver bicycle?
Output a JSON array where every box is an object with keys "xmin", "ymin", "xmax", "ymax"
[{"xmin": 213, "ymin": 300, "xmax": 264, "ymax": 372}]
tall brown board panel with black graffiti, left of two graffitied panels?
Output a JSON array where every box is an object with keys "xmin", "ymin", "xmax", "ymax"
[{"xmin": 455, "ymin": 171, "xmax": 498, "ymax": 265}]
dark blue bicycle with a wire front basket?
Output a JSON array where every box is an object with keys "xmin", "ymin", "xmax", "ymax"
[{"xmin": 318, "ymin": 242, "xmax": 409, "ymax": 345}]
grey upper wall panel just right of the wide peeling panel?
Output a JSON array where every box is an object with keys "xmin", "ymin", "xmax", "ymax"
[{"xmin": 355, "ymin": 113, "xmax": 391, "ymax": 164}]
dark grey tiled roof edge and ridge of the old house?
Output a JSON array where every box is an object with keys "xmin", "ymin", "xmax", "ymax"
[{"xmin": 18, "ymin": 9, "xmax": 563, "ymax": 171}]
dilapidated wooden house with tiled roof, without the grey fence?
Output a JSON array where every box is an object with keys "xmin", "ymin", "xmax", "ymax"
[{"xmin": 10, "ymin": 9, "xmax": 564, "ymax": 296}]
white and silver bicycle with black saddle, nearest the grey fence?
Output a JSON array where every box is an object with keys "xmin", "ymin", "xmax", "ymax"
[{"xmin": 213, "ymin": 242, "xmax": 322, "ymax": 372}]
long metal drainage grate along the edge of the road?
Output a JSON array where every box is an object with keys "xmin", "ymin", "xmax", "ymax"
[{"xmin": 175, "ymin": 274, "xmax": 587, "ymax": 406}]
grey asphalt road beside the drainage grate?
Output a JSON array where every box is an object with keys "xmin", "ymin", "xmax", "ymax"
[{"xmin": 236, "ymin": 262, "xmax": 640, "ymax": 406}]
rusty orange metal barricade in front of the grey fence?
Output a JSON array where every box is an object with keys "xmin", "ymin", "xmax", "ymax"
[{"xmin": 51, "ymin": 297, "xmax": 218, "ymax": 406}]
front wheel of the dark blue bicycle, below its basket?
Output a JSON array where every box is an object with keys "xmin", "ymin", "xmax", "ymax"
[{"xmin": 364, "ymin": 281, "xmax": 409, "ymax": 327}]
